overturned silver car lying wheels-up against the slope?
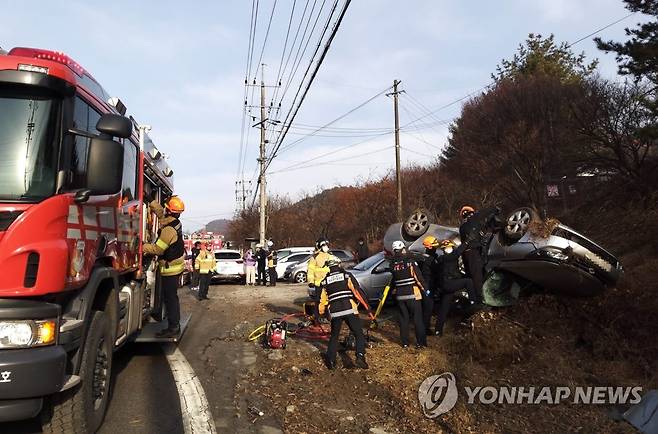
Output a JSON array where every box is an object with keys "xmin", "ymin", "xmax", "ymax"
[{"xmin": 384, "ymin": 208, "xmax": 622, "ymax": 305}]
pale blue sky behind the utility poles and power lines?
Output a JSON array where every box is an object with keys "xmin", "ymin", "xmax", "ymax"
[{"xmin": 0, "ymin": 0, "xmax": 641, "ymax": 231}]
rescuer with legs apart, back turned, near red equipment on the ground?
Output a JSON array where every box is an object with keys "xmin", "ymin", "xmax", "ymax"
[{"xmin": 318, "ymin": 256, "xmax": 368, "ymax": 370}]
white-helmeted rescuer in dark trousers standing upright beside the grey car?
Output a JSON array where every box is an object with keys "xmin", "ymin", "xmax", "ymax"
[{"xmin": 391, "ymin": 241, "xmax": 427, "ymax": 348}]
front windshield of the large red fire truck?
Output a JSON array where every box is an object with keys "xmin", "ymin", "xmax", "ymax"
[{"xmin": 0, "ymin": 86, "xmax": 61, "ymax": 201}]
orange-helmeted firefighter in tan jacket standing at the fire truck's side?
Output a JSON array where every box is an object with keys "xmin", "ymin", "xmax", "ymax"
[{"xmin": 143, "ymin": 196, "xmax": 185, "ymax": 338}]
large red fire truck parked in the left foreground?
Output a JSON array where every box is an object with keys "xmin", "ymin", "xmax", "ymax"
[{"xmin": 0, "ymin": 48, "xmax": 189, "ymax": 433}]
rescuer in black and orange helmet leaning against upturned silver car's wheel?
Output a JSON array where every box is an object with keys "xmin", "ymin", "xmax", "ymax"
[{"xmin": 459, "ymin": 205, "xmax": 500, "ymax": 302}]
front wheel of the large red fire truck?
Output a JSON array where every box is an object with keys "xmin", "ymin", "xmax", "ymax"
[{"xmin": 42, "ymin": 311, "xmax": 112, "ymax": 434}]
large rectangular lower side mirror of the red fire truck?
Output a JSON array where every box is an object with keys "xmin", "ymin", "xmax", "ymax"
[{"xmin": 87, "ymin": 137, "xmax": 123, "ymax": 195}]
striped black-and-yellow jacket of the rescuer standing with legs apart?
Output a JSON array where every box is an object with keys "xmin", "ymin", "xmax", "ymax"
[{"xmin": 318, "ymin": 269, "xmax": 359, "ymax": 319}]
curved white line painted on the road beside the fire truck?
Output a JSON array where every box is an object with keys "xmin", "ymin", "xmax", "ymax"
[{"xmin": 164, "ymin": 344, "xmax": 217, "ymax": 434}]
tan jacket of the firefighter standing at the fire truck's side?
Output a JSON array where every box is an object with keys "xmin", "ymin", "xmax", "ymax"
[{"xmin": 142, "ymin": 200, "xmax": 185, "ymax": 276}]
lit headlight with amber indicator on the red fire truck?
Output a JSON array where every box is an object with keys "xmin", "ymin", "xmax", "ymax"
[{"xmin": 0, "ymin": 319, "xmax": 57, "ymax": 348}]
